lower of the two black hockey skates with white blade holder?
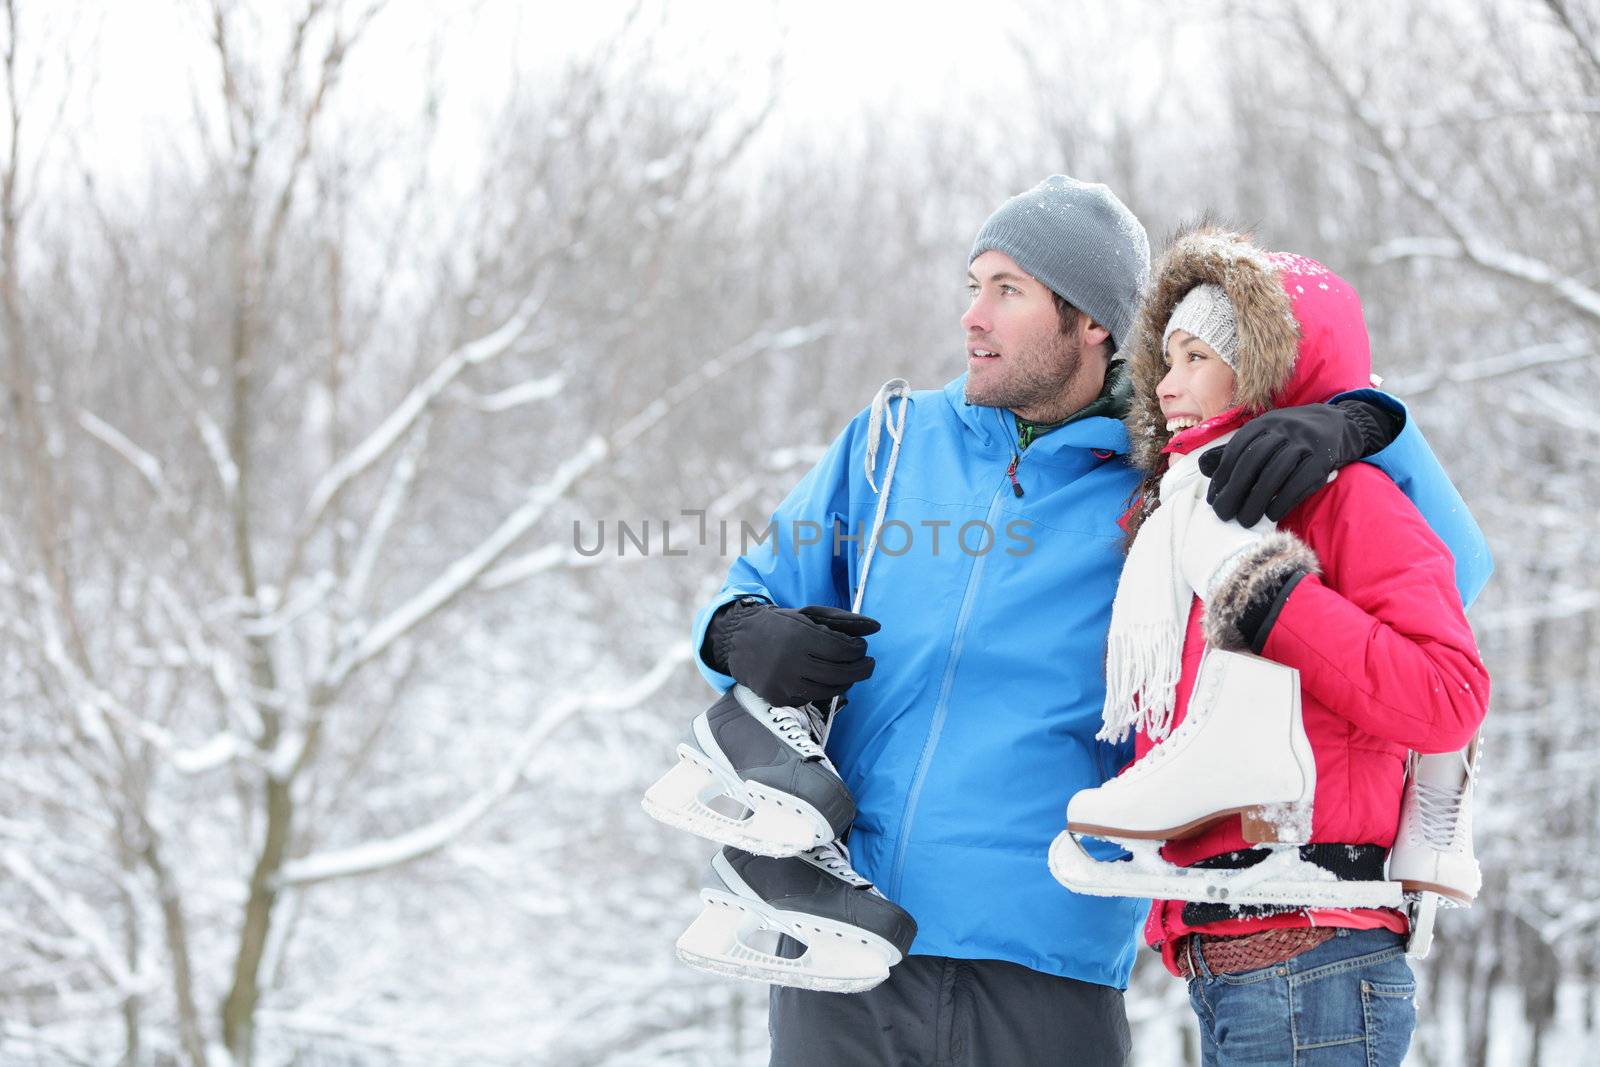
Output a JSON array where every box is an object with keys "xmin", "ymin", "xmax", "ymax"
[{"xmin": 678, "ymin": 843, "xmax": 917, "ymax": 993}]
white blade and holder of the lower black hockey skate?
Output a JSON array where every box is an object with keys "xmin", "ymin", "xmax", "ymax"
[{"xmin": 677, "ymin": 889, "xmax": 901, "ymax": 993}]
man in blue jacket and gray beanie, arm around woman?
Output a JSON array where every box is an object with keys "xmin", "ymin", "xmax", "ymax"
[{"xmin": 694, "ymin": 176, "xmax": 1488, "ymax": 1067}]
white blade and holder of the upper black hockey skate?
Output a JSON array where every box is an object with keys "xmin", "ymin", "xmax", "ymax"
[{"xmin": 642, "ymin": 745, "xmax": 835, "ymax": 857}]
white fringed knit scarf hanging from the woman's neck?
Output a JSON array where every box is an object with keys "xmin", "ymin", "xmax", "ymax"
[{"xmin": 1094, "ymin": 434, "xmax": 1232, "ymax": 742}]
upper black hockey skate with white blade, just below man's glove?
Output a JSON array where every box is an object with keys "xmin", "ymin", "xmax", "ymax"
[{"xmin": 643, "ymin": 685, "xmax": 856, "ymax": 856}]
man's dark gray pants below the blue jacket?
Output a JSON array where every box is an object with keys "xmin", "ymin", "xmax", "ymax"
[{"xmin": 766, "ymin": 957, "xmax": 1131, "ymax": 1067}]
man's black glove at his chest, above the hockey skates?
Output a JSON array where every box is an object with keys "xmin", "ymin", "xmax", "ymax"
[{"xmin": 701, "ymin": 601, "xmax": 878, "ymax": 707}]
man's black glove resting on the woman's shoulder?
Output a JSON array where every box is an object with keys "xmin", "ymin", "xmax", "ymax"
[{"xmin": 1200, "ymin": 398, "xmax": 1400, "ymax": 526}]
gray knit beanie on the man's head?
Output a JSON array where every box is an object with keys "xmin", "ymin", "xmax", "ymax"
[{"xmin": 966, "ymin": 174, "xmax": 1150, "ymax": 347}]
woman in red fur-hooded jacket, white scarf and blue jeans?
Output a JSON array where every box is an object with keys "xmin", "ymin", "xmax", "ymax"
[{"xmin": 1106, "ymin": 227, "xmax": 1488, "ymax": 1064}]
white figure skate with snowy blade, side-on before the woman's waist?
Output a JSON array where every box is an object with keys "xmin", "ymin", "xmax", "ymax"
[{"xmin": 1050, "ymin": 649, "xmax": 1402, "ymax": 907}]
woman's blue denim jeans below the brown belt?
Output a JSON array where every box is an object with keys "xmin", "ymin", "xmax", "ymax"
[{"xmin": 1189, "ymin": 929, "xmax": 1416, "ymax": 1067}]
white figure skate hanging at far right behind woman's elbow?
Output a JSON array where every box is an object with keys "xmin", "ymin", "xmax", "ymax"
[{"xmin": 1389, "ymin": 736, "xmax": 1483, "ymax": 958}]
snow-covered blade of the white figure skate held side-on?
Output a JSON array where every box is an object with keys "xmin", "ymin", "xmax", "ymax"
[{"xmin": 1050, "ymin": 830, "xmax": 1405, "ymax": 907}]
